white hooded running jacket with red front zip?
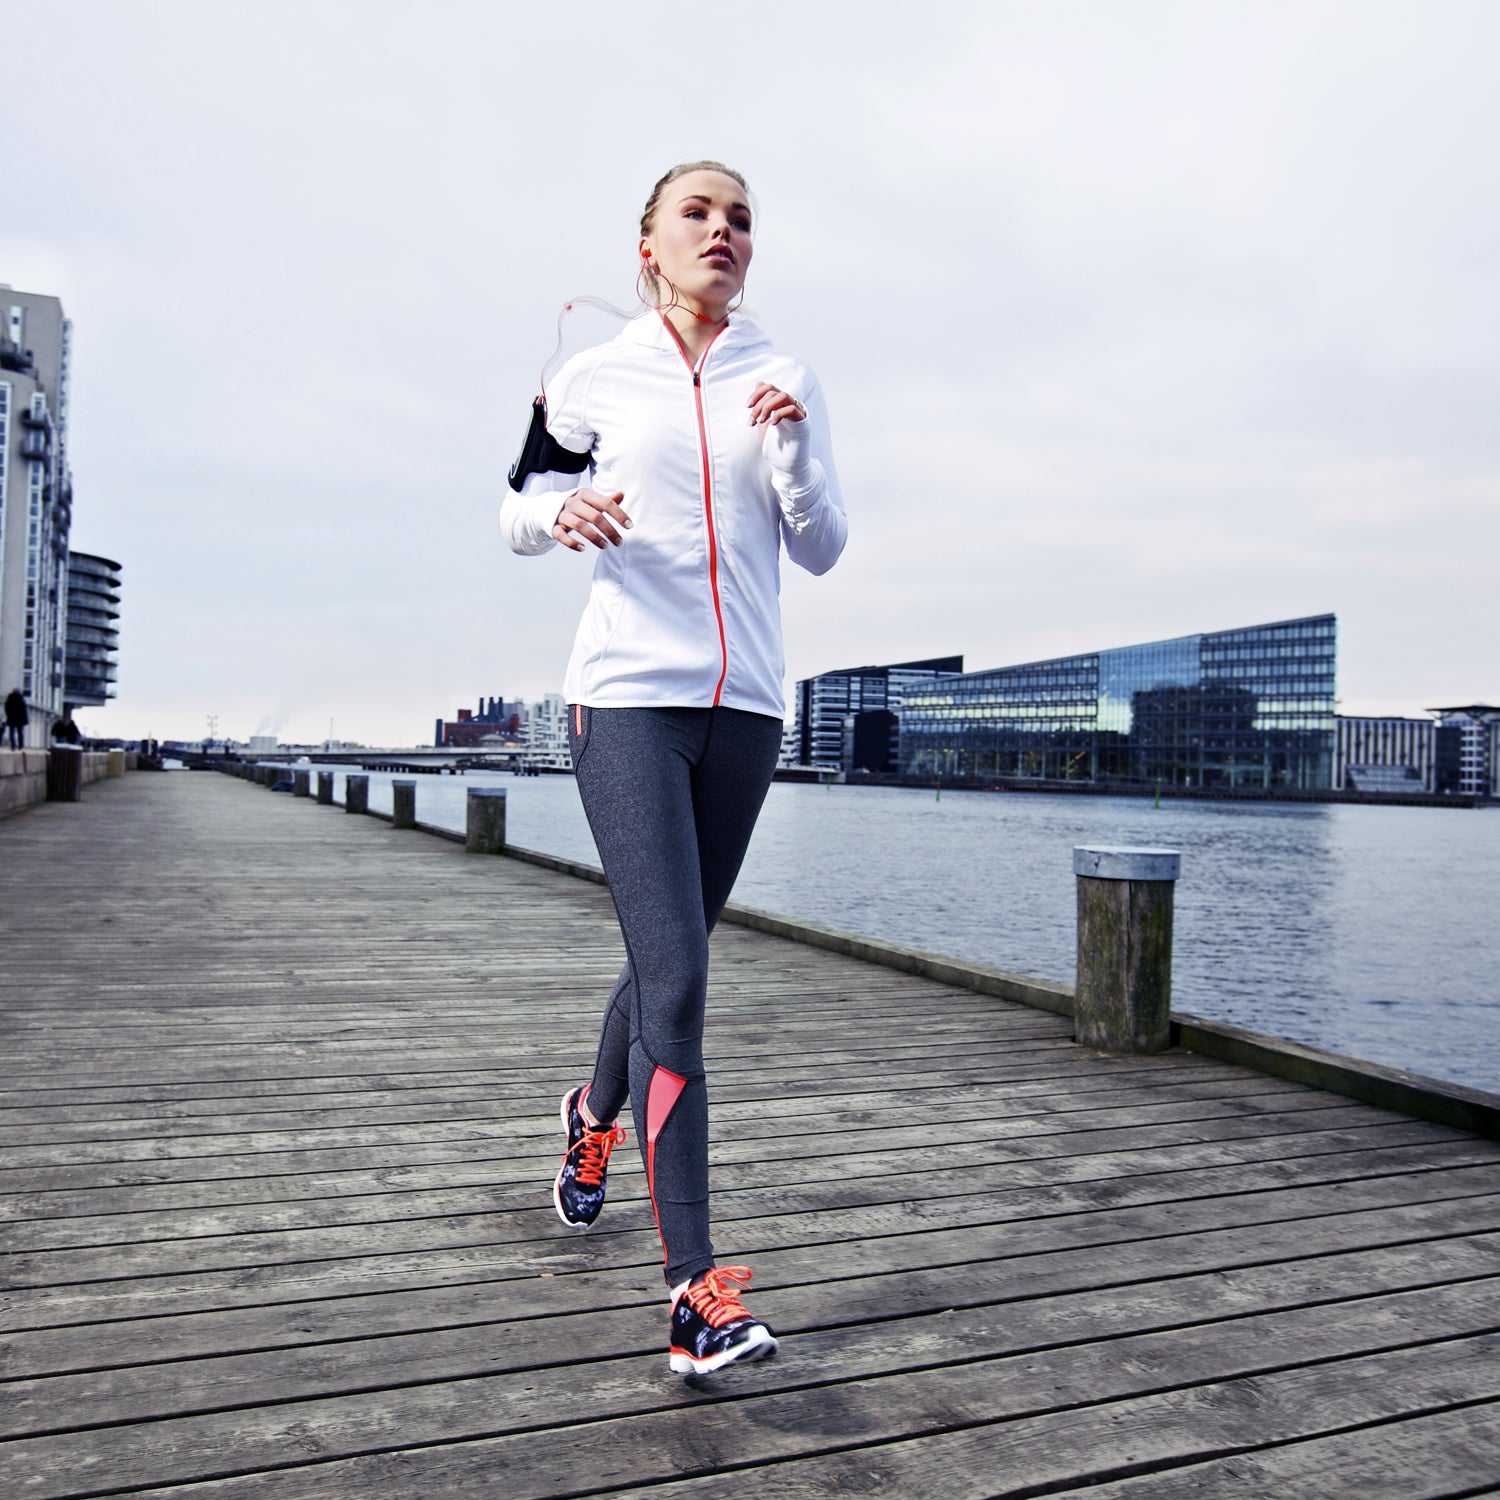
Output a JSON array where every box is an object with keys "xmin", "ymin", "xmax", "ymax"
[{"xmin": 500, "ymin": 314, "xmax": 848, "ymax": 719}]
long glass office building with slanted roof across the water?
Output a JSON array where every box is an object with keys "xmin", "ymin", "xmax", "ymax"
[{"xmin": 900, "ymin": 615, "xmax": 1337, "ymax": 791}]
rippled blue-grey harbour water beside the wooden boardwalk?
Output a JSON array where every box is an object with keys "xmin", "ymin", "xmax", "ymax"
[{"xmin": 307, "ymin": 773, "xmax": 1500, "ymax": 1092}]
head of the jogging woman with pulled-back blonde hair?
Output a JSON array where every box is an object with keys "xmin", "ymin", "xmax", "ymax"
[{"xmin": 641, "ymin": 171, "xmax": 753, "ymax": 318}]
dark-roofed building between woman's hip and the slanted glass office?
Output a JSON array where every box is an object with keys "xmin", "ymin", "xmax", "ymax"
[{"xmin": 783, "ymin": 656, "xmax": 963, "ymax": 771}]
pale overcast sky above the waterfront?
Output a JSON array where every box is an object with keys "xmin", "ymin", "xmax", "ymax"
[{"xmin": 0, "ymin": 0, "xmax": 1500, "ymax": 746}]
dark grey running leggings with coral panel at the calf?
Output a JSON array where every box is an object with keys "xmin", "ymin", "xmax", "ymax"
[{"xmin": 569, "ymin": 704, "xmax": 782, "ymax": 1287}]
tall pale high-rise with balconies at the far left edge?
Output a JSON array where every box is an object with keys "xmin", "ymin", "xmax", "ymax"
[{"xmin": 0, "ymin": 285, "xmax": 72, "ymax": 744}]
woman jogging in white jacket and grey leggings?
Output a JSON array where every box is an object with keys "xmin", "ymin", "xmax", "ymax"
[{"xmin": 501, "ymin": 162, "xmax": 846, "ymax": 1374}]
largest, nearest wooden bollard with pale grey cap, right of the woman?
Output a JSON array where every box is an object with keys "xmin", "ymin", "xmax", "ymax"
[{"xmin": 1073, "ymin": 848, "xmax": 1182, "ymax": 1053}]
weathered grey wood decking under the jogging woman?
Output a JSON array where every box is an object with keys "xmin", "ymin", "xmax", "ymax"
[{"xmin": 0, "ymin": 774, "xmax": 1500, "ymax": 1500}]
